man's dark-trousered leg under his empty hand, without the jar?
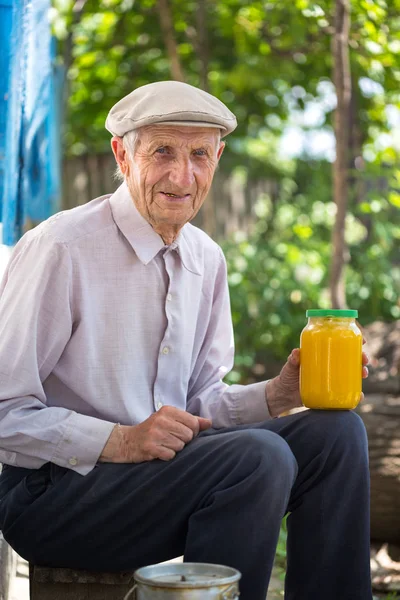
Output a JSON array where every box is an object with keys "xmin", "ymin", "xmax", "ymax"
[{"xmin": 0, "ymin": 429, "xmax": 297, "ymax": 600}]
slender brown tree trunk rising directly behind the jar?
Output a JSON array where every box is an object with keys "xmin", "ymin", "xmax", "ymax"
[{"xmin": 330, "ymin": 0, "xmax": 351, "ymax": 308}]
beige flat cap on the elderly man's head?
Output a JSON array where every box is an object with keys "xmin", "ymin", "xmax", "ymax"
[{"xmin": 106, "ymin": 81, "xmax": 237, "ymax": 137}]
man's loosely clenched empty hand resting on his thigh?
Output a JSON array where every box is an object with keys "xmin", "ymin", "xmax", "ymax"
[{"xmin": 99, "ymin": 406, "xmax": 211, "ymax": 463}]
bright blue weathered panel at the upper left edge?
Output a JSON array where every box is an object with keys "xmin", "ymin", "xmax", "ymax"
[{"xmin": 0, "ymin": 0, "xmax": 62, "ymax": 245}]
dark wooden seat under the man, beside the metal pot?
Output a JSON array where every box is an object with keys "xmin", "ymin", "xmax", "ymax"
[{"xmin": 29, "ymin": 565, "xmax": 134, "ymax": 600}]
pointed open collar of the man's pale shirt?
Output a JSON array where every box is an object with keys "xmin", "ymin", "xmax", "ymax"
[{"xmin": 110, "ymin": 182, "xmax": 202, "ymax": 275}]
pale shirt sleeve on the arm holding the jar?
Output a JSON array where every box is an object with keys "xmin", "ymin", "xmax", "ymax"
[{"xmin": 187, "ymin": 251, "xmax": 271, "ymax": 428}]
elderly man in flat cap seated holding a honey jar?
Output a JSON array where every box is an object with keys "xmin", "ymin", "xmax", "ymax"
[{"xmin": 0, "ymin": 82, "xmax": 371, "ymax": 600}]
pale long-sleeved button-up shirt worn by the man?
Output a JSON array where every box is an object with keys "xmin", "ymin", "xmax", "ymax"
[{"xmin": 0, "ymin": 184, "xmax": 269, "ymax": 475}]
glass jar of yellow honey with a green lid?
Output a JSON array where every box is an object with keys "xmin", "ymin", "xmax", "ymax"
[{"xmin": 300, "ymin": 310, "xmax": 362, "ymax": 410}]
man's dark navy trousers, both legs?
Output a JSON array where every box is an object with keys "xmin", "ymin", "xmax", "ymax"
[{"xmin": 0, "ymin": 411, "xmax": 372, "ymax": 600}]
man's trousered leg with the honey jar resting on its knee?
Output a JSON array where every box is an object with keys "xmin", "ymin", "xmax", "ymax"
[{"xmin": 264, "ymin": 410, "xmax": 372, "ymax": 600}]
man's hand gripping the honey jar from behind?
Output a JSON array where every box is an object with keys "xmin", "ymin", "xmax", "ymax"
[{"xmin": 265, "ymin": 346, "xmax": 369, "ymax": 417}]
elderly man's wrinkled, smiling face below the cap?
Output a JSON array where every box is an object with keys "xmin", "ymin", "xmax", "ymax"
[{"xmin": 113, "ymin": 125, "xmax": 225, "ymax": 239}]
